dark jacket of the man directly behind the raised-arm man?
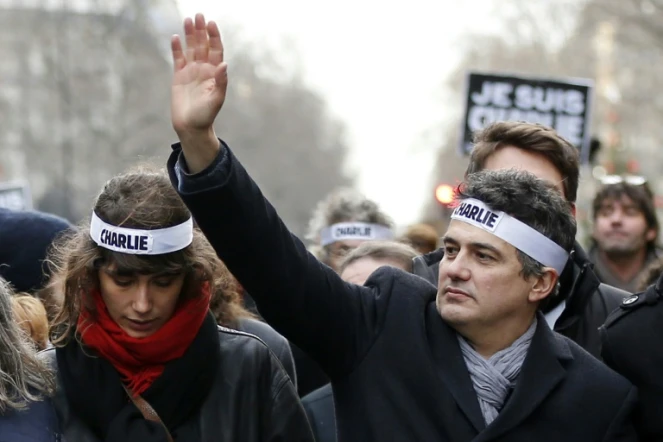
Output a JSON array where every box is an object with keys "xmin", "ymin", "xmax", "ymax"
[{"xmin": 412, "ymin": 243, "xmax": 630, "ymax": 358}]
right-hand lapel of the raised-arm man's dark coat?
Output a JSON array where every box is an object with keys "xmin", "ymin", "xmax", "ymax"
[{"xmin": 474, "ymin": 313, "xmax": 573, "ymax": 442}]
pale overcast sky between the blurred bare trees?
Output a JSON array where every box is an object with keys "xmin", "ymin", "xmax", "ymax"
[{"xmin": 174, "ymin": 0, "xmax": 497, "ymax": 225}]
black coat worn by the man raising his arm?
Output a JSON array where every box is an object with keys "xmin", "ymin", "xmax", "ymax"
[{"xmin": 168, "ymin": 146, "xmax": 636, "ymax": 442}]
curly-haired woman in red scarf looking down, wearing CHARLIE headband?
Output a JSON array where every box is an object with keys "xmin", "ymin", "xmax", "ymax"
[{"xmin": 39, "ymin": 170, "xmax": 313, "ymax": 442}]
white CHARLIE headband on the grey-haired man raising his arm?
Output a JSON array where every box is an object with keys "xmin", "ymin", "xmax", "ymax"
[{"xmin": 451, "ymin": 198, "xmax": 569, "ymax": 274}]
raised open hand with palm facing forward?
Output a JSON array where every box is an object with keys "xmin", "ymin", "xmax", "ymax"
[{"xmin": 171, "ymin": 14, "xmax": 228, "ymax": 133}]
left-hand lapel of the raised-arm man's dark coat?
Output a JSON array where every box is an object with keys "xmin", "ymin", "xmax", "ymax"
[{"xmin": 426, "ymin": 302, "xmax": 486, "ymax": 433}]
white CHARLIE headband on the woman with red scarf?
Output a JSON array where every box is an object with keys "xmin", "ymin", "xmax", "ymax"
[{"xmin": 90, "ymin": 212, "xmax": 193, "ymax": 255}]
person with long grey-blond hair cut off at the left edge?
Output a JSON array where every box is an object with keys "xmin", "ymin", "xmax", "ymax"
[{"xmin": 0, "ymin": 278, "xmax": 61, "ymax": 442}]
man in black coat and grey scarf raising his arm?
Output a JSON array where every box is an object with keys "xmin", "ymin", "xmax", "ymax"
[{"xmin": 168, "ymin": 14, "xmax": 636, "ymax": 442}]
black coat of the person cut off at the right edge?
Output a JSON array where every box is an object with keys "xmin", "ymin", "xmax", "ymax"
[{"xmin": 601, "ymin": 276, "xmax": 663, "ymax": 442}]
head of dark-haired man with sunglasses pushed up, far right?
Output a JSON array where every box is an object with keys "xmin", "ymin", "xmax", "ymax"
[{"xmin": 589, "ymin": 175, "xmax": 662, "ymax": 292}]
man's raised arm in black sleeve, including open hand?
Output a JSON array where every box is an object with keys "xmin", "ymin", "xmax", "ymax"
[{"xmin": 168, "ymin": 14, "xmax": 388, "ymax": 377}]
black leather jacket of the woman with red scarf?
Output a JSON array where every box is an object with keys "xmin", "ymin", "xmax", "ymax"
[{"xmin": 40, "ymin": 327, "xmax": 313, "ymax": 442}]
